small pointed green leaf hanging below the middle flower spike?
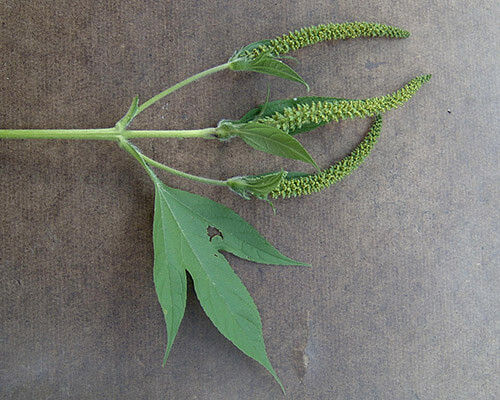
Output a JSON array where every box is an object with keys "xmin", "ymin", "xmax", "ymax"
[{"xmin": 218, "ymin": 121, "xmax": 318, "ymax": 169}]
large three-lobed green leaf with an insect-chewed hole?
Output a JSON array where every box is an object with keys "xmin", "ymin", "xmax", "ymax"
[{"xmin": 152, "ymin": 179, "xmax": 306, "ymax": 388}]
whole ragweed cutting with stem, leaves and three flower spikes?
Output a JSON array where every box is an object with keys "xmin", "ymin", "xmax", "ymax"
[{"xmin": 0, "ymin": 22, "xmax": 430, "ymax": 389}]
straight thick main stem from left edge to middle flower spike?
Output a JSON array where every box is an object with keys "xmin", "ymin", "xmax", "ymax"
[{"xmin": 0, "ymin": 128, "xmax": 216, "ymax": 141}]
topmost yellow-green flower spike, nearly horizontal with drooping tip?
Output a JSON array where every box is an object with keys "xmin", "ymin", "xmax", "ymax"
[{"xmin": 245, "ymin": 22, "xmax": 410, "ymax": 58}]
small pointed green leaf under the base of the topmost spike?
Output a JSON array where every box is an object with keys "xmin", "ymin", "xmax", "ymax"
[{"xmin": 229, "ymin": 53, "xmax": 309, "ymax": 91}]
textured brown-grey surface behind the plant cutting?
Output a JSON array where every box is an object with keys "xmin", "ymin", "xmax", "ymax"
[{"xmin": 0, "ymin": 0, "xmax": 500, "ymax": 400}]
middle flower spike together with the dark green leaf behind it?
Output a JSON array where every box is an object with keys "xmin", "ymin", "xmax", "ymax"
[{"xmin": 239, "ymin": 75, "xmax": 431, "ymax": 135}]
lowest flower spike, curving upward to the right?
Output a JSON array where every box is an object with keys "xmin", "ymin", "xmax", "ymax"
[{"xmin": 270, "ymin": 114, "xmax": 382, "ymax": 198}]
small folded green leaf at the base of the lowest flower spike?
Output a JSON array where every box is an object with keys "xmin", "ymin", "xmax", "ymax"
[{"xmin": 227, "ymin": 170, "xmax": 287, "ymax": 200}]
